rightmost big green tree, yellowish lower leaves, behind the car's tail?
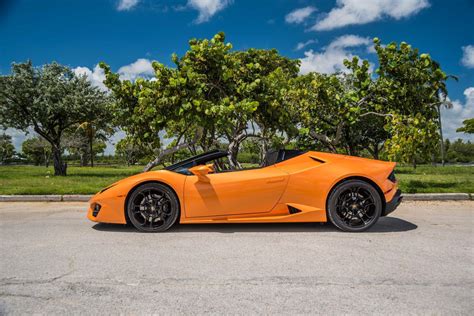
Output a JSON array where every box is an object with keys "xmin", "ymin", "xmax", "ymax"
[{"xmin": 374, "ymin": 39, "xmax": 448, "ymax": 166}]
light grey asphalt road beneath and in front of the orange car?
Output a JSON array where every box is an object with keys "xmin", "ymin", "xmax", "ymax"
[{"xmin": 0, "ymin": 202, "xmax": 474, "ymax": 315}]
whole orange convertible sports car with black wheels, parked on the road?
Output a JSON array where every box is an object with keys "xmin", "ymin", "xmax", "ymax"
[{"xmin": 88, "ymin": 150, "xmax": 402, "ymax": 232}]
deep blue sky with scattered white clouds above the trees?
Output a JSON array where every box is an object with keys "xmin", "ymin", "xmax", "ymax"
[{"xmin": 0, "ymin": 0, "xmax": 474, "ymax": 152}]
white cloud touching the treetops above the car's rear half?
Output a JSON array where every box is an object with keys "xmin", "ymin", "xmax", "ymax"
[{"xmin": 300, "ymin": 35, "xmax": 371, "ymax": 74}]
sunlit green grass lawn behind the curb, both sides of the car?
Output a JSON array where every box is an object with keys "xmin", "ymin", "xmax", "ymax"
[{"xmin": 0, "ymin": 166, "xmax": 474, "ymax": 194}]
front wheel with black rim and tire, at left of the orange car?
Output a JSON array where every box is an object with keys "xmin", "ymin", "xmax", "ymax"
[{"xmin": 127, "ymin": 183, "xmax": 179, "ymax": 233}]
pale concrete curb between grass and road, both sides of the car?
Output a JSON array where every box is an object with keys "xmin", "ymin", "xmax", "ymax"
[{"xmin": 0, "ymin": 193, "xmax": 474, "ymax": 202}]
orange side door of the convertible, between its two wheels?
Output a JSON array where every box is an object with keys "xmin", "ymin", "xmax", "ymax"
[{"xmin": 184, "ymin": 166, "xmax": 288, "ymax": 217}]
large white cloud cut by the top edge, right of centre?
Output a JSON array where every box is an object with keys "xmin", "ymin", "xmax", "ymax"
[{"xmin": 311, "ymin": 0, "xmax": 430, "ymax": 31}]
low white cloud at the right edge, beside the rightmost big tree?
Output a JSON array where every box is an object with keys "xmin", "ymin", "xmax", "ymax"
[{"xmin": 441, "ymin": 87, "xmax": 474, "ymax": 141}]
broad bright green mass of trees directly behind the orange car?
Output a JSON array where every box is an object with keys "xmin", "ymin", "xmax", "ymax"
[{"xmin": 101, "ymin": 33, "xmax": 448, "ymax": 170}]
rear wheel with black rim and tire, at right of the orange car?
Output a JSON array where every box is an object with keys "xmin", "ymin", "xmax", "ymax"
[{"xmin": 328, "ymin": 180, "xmax": 382, "ymax": 232}]
